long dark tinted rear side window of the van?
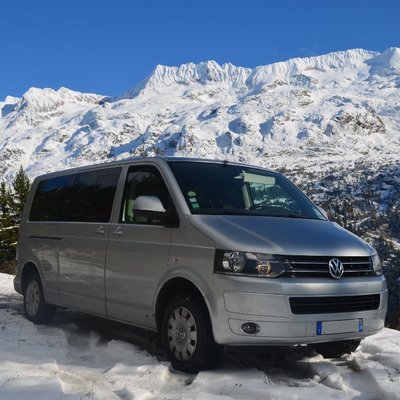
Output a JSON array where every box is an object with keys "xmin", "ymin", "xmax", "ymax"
[{"xmin": 29, "ymin": 167, "xmax": 121, "ymax": 222}]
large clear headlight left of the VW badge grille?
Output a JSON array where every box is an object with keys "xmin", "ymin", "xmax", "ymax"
[{"xmin": 214, "ymin": 250, "xmax": 286, "ymax": 278}]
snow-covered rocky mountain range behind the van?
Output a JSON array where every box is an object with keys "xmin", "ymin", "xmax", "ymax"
[{"xmin": 0, "ymin": 48, "xmax": 400, "ymax": 179}]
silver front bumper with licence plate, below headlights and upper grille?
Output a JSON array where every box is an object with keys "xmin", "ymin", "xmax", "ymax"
[{"xmin": 208, "ymin": 274, "xmax": 387, "ymax": 345}]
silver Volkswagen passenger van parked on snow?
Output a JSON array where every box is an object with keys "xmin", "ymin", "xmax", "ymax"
[{"xmin": 14, "ymin": 158, "xmax": 387, "ymax": 372}]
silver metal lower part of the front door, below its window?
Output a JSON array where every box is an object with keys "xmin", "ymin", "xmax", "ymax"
[{"xmin": 106, "ymin": 224, "xmax": 171, "ymax": 326}]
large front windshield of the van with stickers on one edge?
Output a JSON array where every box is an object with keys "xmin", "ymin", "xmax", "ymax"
[{"xmin": 169, "ymin": 161, "xmax": 325, "ymax": 220}]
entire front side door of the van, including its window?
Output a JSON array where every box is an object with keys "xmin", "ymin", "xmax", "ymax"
[{"xmin": 106, "ymin": 166, "xmax": 173, "ymax": 326}]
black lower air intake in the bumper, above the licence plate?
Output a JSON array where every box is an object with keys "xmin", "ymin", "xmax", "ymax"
[{"xmin": 289, "ymin": 294, "xmax": 380, "ymax": 314}]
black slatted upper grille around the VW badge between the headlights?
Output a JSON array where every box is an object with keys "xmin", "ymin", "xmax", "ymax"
[{"xmin": 286, "ymin": 256, "xmax": 375, "ymax": 277}]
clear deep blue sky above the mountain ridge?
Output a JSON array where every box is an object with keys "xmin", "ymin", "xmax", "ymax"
[{"xmin": 0, "ymin": 0, "xmax": 400, "ymax": 100}]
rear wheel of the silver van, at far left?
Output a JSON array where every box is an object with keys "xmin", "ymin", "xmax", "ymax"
[{"xmin": 24, "ymin": 273, "xmax": 56, "ymax": 324}]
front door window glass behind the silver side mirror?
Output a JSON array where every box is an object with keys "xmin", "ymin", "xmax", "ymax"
[{"xmin": 119, "ymin": 167, "xmax": 172, "ymax": 225}]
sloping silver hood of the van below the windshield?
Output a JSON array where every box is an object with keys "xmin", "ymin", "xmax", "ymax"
[{"xmin": 190, "ymin": 215, "xmax": 374, "ymax": 257}]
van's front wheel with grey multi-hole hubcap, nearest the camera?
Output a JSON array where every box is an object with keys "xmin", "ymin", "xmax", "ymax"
[{"xmin": 161, "ymin": 295, "xmax": 223, "ymax": 374}]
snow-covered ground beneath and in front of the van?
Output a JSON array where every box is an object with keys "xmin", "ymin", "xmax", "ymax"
[{"xmin": 0, "ymin": 274, "xmax": 400, "ymax": 400}]
